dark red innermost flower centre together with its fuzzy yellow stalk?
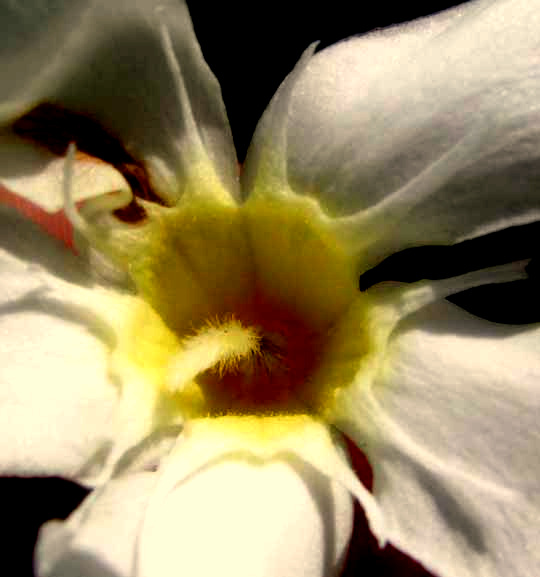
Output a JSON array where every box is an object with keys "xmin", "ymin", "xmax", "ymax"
[{"xmin": 170, "ymin": 296, "xmax": 324, "ymax": 414}]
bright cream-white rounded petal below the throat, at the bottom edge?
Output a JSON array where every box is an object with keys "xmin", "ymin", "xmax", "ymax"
[{"xmin": 140, "ymin": 457, "xmax": 352, "ymax": 577}]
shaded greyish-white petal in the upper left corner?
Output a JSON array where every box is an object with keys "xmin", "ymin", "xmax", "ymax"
[{"xmin": 0, "ymin": 0, "xmax": 237, "ymax": 205}]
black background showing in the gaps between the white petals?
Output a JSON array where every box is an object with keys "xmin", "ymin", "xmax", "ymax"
[{"xmin": 4, "ymin": 0, "xmax": 540, "ymax": 577}]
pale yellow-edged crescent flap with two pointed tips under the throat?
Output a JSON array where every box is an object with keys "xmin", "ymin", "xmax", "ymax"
[{"xmin": 139, "ymin": 415, "xmax": 386, "ymax": 546}]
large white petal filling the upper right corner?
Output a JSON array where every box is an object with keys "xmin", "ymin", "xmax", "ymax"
[{"xmin": 268, "ymin": 0, "xmax": 540, "ymax": 267}]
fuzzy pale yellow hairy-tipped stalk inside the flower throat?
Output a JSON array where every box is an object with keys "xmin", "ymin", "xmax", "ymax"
[{"xmin": 167, "ymin": 319, "xmax": 261, "ymax": 392}]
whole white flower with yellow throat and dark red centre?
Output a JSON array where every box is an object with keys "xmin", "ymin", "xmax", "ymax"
[{"xmin": 0, "ymin": 0, "xmax": 540, "ymax": 577}]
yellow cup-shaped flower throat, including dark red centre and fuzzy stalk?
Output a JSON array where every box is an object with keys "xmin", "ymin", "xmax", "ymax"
[{"xmin": 102, "ymin": 187, "xmax": 370, "ymax": 419}]
